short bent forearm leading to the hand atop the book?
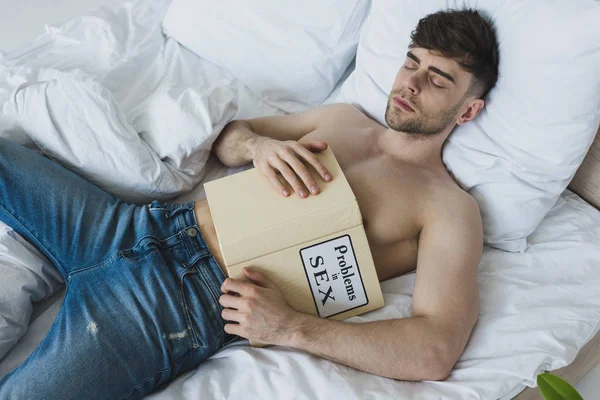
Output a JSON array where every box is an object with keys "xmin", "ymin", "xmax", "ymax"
[{"xmin": 212, "ymin": 121, "xmax": 264, "ymax": 167}]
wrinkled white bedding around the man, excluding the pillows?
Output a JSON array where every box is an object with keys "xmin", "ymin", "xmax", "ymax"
[{"xmin": 0, "ymin": 0, "xmax": 600, "ymax": 400}]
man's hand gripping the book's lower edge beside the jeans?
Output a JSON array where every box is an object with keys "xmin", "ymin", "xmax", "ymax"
[{"xmin": 219, "ymin": 268, "xmax": 303, "ymax": 346}]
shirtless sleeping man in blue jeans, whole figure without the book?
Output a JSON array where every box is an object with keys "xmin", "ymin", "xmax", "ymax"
[{"xmin": 0, "ymin": 7, "xmax": 498, "ymax": 399}]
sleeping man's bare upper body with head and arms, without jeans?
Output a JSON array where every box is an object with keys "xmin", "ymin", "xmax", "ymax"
[{"xmin": 204, "ymin": 5, "xmax": 498, "ymax": 380}]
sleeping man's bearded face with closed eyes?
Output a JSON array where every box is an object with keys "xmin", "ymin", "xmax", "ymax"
[{"xmin": 385, "ymin": 47, "xmax": 471, "ymax": 137}]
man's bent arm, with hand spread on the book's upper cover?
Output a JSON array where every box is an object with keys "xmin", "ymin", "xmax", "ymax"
[{"xmin": 213, "ymin": 104, "xmax": 348, "ymax": 197}]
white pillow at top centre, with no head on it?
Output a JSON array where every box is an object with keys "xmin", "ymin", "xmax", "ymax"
[{"xmin": 163, "ymin": 0, "xmax": 370, "ymax": 112}]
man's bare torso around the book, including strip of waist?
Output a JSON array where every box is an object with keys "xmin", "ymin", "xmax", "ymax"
[{"xmin": 195, "ymin": 105, "xmax": 460, "ymax": 281}]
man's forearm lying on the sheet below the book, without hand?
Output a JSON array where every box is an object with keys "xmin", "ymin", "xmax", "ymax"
[{"xmin": 286, "ymin": 314, "xmax": 449, "ymax": 380}]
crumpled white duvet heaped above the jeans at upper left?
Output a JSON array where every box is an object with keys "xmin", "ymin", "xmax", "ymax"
[{"xmin": 0, "ymin": 1, "xmax": 284, "ymax": 203}]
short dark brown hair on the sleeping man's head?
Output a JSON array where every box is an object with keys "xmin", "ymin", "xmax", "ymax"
[{"xmin": 409, "ymin": 9, "xmax": 498, "ymax": 99}]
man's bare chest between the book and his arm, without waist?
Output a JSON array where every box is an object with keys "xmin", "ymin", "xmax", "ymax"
[{"xmin": 302, "ymin": 129, "xmax": 425, "ymax": 281}]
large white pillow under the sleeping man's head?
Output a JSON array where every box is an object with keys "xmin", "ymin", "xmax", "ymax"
[{"xmin": 338, "ymin": 0, "xmax": 600, "ymax": 252}]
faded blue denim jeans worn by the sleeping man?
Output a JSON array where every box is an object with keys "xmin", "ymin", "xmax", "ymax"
[{"xmin": 0, "ymin": 139, "xmax": 239, "ymax": 400}]
